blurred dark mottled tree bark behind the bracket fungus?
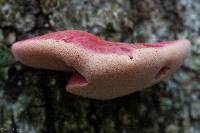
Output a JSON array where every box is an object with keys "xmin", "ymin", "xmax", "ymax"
[{"xmin": 0, "ymin": 0, "xmax": 200, "ymax": 133}]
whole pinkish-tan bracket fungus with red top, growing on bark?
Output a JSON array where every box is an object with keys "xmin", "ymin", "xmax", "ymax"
[{"xmin": 12, "ymin": 30, "xmax": 190, "ymax": 100}]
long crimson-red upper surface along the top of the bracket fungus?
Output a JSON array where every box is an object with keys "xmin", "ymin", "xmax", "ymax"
[{"xmin": 30, "ymin": 30, "xmax": 169, "ymax": 56}]
